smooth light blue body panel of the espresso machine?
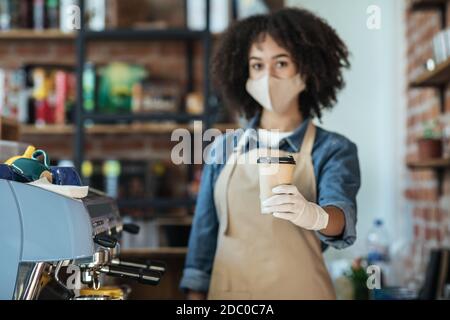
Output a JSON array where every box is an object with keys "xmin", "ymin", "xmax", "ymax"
[{"xmin": 0, "ymin": 179, "xmax": 94, "ymax": 300}]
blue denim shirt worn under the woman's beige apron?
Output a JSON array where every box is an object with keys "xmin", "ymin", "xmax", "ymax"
[{"xmin": 180, "ymin": 116, "xmax": 360, "ymax": 292}]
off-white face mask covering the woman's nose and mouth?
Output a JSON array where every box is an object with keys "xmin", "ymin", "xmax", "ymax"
[{"xmin": 246, "ymin": 74, "xmax": 306, "ymax": 113}]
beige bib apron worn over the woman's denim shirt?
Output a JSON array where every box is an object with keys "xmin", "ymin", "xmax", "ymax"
[{"xmin": 208, "ymin": 122, "xmax": 335, "ymax": 300}]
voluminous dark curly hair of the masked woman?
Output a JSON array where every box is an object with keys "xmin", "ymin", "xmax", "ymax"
[{"xmin": 211, "ymin": 8, "xmax": 350, "ymax": 119}]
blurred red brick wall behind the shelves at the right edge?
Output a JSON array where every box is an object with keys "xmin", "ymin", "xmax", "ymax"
[{"xmin": 405, "ymin": 1, "xmax": 450, "ymax": 278}]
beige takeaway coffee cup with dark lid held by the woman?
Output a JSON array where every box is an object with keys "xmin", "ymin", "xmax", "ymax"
[{"xmin": 258, "ymin": 156, "xmax": 296, "ymax": 214}]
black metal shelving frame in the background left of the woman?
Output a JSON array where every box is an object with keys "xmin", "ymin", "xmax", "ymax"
[{"xmin": 74, "ymin": 0, "xmax": 214, "ymax": 208}]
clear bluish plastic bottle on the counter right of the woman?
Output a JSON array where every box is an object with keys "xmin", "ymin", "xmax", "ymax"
[{"xmin": 367, "ymin": 219, "xmax": 390, "ymax": 265}]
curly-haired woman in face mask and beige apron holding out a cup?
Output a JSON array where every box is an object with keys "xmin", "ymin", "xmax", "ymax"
[{"xmin": 180, "ymin": 8, "xmax": 360, "ymax": 299}]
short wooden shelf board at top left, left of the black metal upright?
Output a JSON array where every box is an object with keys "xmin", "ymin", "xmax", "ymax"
[{"xmin": 0, "ymin": 29, "xmax": 76, "ymax": 40}]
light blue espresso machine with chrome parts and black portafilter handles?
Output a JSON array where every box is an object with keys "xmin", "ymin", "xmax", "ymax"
[{"xmin": 0, "ymin": 179, "xmax": 165, "ymax": 300}]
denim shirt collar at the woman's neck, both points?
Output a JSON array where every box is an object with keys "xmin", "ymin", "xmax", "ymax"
[{"xmin": 245, "ymin": 112, "xmax": 311, "ymax": 152}]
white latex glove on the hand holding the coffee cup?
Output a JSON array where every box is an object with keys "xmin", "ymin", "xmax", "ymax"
[{"xmin": 262, "ymin": 185, "xmax": 328, "ymax": 231}]
